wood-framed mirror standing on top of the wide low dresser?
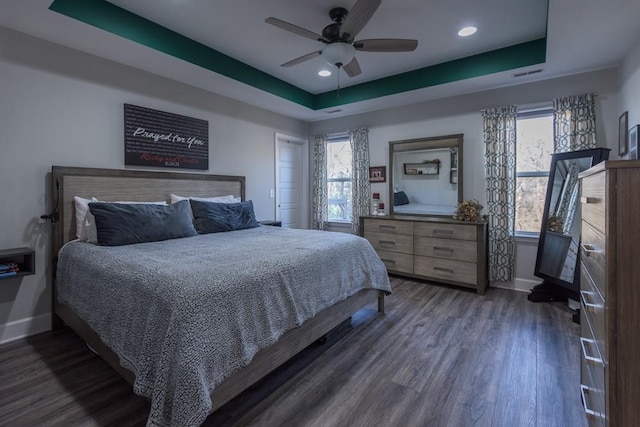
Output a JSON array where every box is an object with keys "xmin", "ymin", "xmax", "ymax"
[{"xmin": 388, "ymin": 134, "xmax": 464, "ymax": 217}]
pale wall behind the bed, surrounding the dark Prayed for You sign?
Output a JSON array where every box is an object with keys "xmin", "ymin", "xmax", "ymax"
[{"xmin": 0, "ymin": 27, "xmax": 308, "ymax": 342}]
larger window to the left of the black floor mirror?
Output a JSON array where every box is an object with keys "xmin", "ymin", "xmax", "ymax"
[{"xmin": 516, "ymin": 109, "xmax": 553, "ymax": 235}]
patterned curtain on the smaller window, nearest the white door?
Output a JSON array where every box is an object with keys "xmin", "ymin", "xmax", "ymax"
[{"xmin": 311, "ymin": 135, "xmax": 329, "ymax": 230}]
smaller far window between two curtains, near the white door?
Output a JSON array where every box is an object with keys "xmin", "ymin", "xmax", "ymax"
[{"xmin": 327, "ymin": 135, "xmax": 352, "ymax": 222}]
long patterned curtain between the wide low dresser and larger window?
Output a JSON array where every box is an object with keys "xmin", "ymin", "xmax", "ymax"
[{"xmin": 482, "ymin": 106, "xmax": 517, "ymax": 281}]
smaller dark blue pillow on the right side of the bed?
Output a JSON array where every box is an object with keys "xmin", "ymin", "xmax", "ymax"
[{"xmin": 189, "ymin": 199, "xmax": 260, "ymax": 234}]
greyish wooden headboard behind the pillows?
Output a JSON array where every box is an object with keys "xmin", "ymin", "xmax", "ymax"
[{"xmin": 51, "ymin": 166, "xmax": 245, "ymax": 260}]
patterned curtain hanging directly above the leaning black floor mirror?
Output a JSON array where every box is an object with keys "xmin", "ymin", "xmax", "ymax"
[{"xmin": 553, "ymin": 93, "xmax": 596, "ymax": 153}]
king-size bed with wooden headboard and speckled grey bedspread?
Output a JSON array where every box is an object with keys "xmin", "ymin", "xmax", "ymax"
[{"xmin": 51, "ymin": 166, "xmax": 391, "ymax": 425}]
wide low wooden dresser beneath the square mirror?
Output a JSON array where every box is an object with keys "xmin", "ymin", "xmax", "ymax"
[{"xmin": 360, "ymin": 215, "xmax": 489, "ymax": 295}]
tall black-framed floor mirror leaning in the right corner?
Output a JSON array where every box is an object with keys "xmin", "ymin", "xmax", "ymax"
[{"xmin": 529, "ymin": 148, "xmax": 610, "ymax": 302}]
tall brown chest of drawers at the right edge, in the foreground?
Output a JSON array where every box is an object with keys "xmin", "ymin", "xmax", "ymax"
[{"xmin": 580, "ymin": 160, "xmax": 640, "ymax": 427}]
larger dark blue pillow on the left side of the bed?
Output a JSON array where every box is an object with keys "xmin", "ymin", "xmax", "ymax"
[{"xmin": 89, "ymin": 200, "xmax": 198, "ymax": 246}]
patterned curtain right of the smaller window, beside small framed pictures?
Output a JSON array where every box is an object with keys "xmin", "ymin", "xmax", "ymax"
[{"xmin": 349, "ymin": 128, "xmax": 371, "ymax": 234}]
